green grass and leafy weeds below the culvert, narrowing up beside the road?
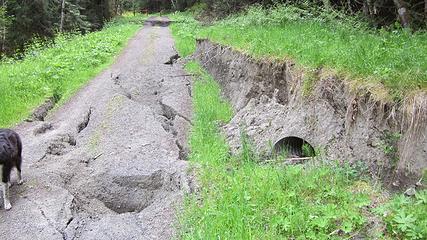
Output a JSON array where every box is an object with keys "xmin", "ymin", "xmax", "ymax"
[{"xmin": 172, "ymin": 16, "xmax": 427, "ymax": 239}]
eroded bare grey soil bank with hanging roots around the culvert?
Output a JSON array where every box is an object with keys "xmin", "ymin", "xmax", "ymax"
[{"xmin": 195, "ymin": 40, "xmax": 427, "ymax": 188}]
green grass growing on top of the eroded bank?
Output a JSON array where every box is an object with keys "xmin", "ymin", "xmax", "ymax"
[{"xmin": 171, "ymin": 6, "xmax": 427, "ymax": 99}]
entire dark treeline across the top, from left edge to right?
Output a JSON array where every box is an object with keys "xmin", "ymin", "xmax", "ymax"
[{"xmin": 0, "ymin": 0, "xmax": 427, "ymax": 58}]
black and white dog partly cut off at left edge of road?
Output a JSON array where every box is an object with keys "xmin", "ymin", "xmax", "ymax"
[{"xmin": 0, "ymin": 129, "xmax": 22, "ymax": 210}]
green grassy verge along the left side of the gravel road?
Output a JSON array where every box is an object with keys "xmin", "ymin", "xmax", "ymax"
[{"xmin": 0, "ymin": 15, "xmax": 143, "ymax": 127}]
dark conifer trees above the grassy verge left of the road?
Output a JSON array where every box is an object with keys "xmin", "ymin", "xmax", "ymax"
[{"xmin": 0, "ymin": 0, "xmax": 116, "ymax": 57}]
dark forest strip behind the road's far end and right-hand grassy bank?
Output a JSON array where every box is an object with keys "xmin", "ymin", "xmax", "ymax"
[{"xmin": 133, "ymin": 0, "xmax": 427, "ymax": 29}]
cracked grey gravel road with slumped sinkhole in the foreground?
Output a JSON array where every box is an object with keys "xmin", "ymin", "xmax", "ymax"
[{"xmin": 0, "ymin": 15, "xmax": 191, "ymax": 240}]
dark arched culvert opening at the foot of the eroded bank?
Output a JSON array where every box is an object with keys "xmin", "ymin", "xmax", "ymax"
[{"xmin": 274, "ymin": 136, "xmax": 316, "ymax": 158}]
